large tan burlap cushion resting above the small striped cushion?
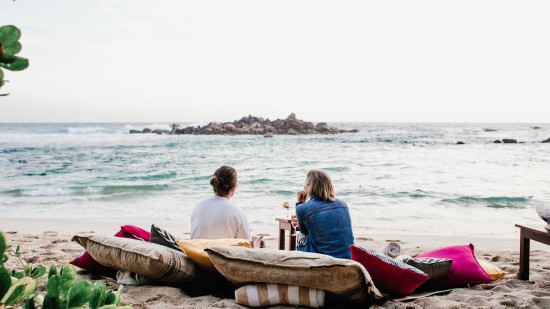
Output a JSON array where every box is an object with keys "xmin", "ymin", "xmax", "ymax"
[{"xmin": 205, "ymin": 246, "xmax": 382, "ymax": 301}]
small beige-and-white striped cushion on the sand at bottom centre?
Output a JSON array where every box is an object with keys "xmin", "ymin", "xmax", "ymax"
[{"xmin": 235, "ymin": 283, "xmax": 325, "ymax": 308}]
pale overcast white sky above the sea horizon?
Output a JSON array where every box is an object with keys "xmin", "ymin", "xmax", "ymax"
[{"xmin": 0, "ymin": 0, "xmax": 550, "ymax": 123}]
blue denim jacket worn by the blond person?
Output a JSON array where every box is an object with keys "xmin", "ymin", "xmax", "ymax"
[{"xmin": 296, "ymin": 196, "xmax": 354, "ymax": 259}]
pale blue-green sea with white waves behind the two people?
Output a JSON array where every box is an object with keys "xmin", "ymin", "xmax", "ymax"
[{"xmin": 0, "ymin": 123, "xmax": 550, "ymax": 238}]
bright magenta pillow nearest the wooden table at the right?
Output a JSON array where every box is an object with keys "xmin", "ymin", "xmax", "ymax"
[{"xmin": 417, "ymin": 244, "xmax": 493, "ymax": 288}]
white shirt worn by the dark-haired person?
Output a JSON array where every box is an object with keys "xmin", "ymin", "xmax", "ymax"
[{"xmin": 191, "ymin": 195, "xmax": 251, "ymax": 241}]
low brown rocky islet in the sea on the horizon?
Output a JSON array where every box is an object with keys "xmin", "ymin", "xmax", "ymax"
[{"xmin": 130, "ymin": 113, "xmax": 359, "ymax": 137}]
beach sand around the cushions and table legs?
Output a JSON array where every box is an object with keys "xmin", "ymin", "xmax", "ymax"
[{"xmin": 0, "ymin": 218, "xmax": 550, "ymax": 309}]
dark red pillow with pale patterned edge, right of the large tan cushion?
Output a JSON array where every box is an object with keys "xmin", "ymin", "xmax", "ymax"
[{"xmin": 350, "ymin": 245, "xmax": 428, "ymax": 295}]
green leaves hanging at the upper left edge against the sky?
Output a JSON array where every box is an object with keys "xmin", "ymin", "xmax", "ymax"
[{"xmin": 0, "ymin": 25, "xmax": 29, "ymax": 96}]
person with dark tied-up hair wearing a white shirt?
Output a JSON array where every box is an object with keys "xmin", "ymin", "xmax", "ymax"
[{"xmin": 191, "ymin": 165, "xmax": 265, "ymax": 247}]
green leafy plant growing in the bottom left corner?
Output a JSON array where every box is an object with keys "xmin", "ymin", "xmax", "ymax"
[{"xmin": 0, "ymin": 232, "xmax": 132, "ymax": 309}]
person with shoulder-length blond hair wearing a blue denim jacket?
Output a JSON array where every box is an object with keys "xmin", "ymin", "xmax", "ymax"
[{"xmin": 293, "ymin": 170, "xmax": 354, "ymax": 259}]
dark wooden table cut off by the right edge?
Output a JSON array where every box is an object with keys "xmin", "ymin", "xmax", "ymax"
[{"xmin": 516, "ymin": 224, "xmax": 550, "ymax": 280}]
